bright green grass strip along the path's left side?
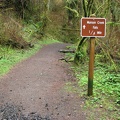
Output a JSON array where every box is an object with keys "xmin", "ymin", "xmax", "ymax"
[{"xmin": 0, "ymin": 37, "xmax": 58, "ymax": 76}]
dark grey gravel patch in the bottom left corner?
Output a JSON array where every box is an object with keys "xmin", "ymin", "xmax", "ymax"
[{"xmin": 0, "ymin": 103, "xmax": 51, "ymax": 120}]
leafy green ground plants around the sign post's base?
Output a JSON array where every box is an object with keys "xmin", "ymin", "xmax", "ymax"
[{"xmin": 74, "ymin": 62, "xmax": 120, "ymax": 119}]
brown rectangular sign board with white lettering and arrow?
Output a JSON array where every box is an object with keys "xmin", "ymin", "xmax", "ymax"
[{"xmin": 81, "ymin": 18, "xmax": 106, "ymax": 37}]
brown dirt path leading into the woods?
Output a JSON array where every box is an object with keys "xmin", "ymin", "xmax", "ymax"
[{"xmin": 0, "ymin": 43, "xmax": 85, "ymax": 120}]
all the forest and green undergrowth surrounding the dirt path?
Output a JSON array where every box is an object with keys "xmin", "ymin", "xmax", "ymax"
[{"xmin": 0, "ymin": 0, "xmax": 120, "ymax": 120}]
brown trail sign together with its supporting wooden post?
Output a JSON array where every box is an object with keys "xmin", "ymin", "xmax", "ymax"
[{"xmin": 81, "ymin": 15, "xmax": 106, "ymax": 96}]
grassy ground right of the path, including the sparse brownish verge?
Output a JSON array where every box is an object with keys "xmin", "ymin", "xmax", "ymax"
[{"xmin": 63, "ymin": 47, "xmax": 120, "ymax": 120}]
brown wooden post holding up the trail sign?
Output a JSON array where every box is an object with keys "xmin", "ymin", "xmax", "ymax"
[{"xmin": 88, "ymin": 15, "xmax": 95, "ymax": 96}]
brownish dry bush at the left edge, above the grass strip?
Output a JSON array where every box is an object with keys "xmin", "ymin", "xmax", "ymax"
[{"xmin": 0, "ymin": 15, "xmax": 29, "ymax": 49}]
